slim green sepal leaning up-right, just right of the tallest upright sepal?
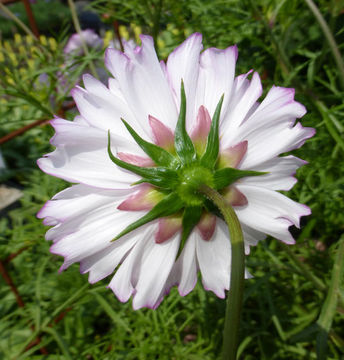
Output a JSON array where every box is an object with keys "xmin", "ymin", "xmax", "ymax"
[{"xmin": 201, "ymin": 95, "xmax": 224, "ymax": 169}]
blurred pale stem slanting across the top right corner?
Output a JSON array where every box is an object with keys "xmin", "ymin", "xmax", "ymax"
[{"xmin": 305, "ymin": 0, "xmax": 344, "ymax": 88}]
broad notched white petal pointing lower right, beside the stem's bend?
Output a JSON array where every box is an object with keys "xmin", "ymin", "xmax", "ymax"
[{"xmin": 235, "ymin": 184, "xmax": 310, "ymax": 244}]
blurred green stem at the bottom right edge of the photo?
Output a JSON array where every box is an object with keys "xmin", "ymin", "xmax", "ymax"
[{"xmin": 316, "ymin": 235, "xmax": 344, "ymax": 360}]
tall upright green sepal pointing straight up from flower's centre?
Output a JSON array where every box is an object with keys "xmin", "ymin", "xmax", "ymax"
[{"xmin": 174, "ymin": 80, "xmax": 196, "ymax": 164}]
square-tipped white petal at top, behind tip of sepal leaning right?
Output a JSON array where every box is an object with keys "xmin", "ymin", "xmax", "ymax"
[{"xmin": 195, "ymin": 46, "xmax": 238, "ymax": 118}]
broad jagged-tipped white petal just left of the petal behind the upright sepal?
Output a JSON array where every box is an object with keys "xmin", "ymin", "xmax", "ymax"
[{"xmin": 105, "ymin": 35, "xmax": 178, "ymax": 136}]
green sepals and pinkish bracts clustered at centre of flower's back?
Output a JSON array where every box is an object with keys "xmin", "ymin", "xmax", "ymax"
[{"xmin": 108, "ymin": 82, "xmax": 266, "ymax": 248}]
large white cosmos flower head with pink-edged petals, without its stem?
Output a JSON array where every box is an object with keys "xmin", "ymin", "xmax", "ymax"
[{"xmin": 38, "ymin": 34, "xmax": 314, "ymax": 309}]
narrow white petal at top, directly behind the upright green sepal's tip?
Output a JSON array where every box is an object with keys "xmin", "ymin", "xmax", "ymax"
[{"xmin": 166, "ymin": 33, "xmax": 203, "ymax": 130}]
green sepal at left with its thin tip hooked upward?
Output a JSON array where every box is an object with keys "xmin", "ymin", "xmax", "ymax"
[{"xmin": 108, "ymin": 131, "xmax": 178, "ymax": 189}]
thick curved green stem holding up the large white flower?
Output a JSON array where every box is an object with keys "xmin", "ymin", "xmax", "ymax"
[{"xmin": 200, "ymin": 185, "xmax": 245, "ymax": 360}]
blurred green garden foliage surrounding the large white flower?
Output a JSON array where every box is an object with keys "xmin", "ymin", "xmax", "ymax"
[{"xmin": 0, "ymin": 0, "xmax": 344, "ymax": 360}]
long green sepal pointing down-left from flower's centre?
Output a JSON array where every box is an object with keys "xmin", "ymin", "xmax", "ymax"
[{"xmin": 112, "ymin": 193, "xmax": 184, "ymax": 241}]
